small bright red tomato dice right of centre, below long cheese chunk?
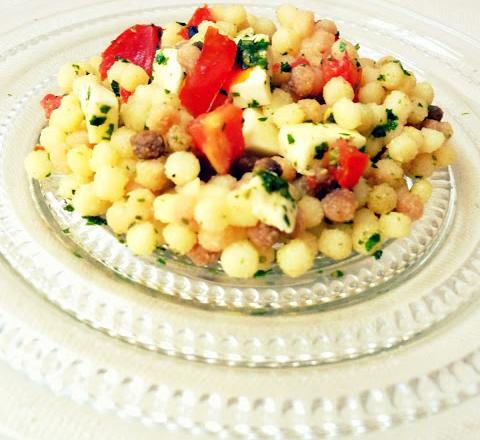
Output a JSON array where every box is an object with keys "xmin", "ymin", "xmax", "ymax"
[{"xmin": 332, "ymin": 139, "xmax": 369, "ymax": 189}]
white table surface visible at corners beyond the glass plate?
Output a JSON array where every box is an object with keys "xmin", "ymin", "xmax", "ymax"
[{"xmin": 0, "ymin": 0, "xmax": 480, "ymax": 440}]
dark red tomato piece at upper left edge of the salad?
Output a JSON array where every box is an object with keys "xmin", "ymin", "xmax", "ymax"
[{"xmin": 99, "ymin": 24, "xmax": 162, "ymax": 79}]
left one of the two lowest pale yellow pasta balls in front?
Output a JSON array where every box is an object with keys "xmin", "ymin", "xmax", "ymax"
[{"xmin": 220, "ymin": 240, "xmax": 259, "ymax": 278}]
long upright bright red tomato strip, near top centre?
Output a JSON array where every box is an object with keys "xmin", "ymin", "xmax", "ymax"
[{"xmin": 180, "ymin": 27, "xmax": 237, "ymax": 116}]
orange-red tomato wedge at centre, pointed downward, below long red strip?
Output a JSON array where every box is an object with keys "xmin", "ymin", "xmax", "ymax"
[{"xmin": 188, "ymin": 103, "xmax": 245, "ymax": 174}]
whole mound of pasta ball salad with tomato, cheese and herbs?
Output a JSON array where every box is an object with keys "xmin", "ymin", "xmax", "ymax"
[{"xmin": 25, "ymin": 5, "xmax": 454, "ymax": 278}]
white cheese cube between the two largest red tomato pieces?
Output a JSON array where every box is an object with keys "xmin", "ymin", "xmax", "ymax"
[{"xmin": 152, "ymin": 48, "xmax": 185, "ymax": 94}]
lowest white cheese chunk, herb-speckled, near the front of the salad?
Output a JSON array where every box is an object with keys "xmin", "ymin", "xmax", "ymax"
[{"xmin": 232, "ymin": 173, "xmax": 297, "ymax": 233}]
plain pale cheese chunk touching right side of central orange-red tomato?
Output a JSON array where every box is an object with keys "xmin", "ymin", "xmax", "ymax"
[{"xmin": 243, "ymin": 108, "xmax": 280, "ymax": 155}]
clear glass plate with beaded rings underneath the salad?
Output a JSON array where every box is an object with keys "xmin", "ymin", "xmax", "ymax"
[{"xmin": 0, "ymin": 0, "xmax": 480, "ymax": 438}]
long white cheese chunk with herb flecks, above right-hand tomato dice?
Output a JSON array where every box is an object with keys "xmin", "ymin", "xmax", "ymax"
[{"xmin": 279, "ymin": 123, "xmax": 366, "ymax": 176}]
